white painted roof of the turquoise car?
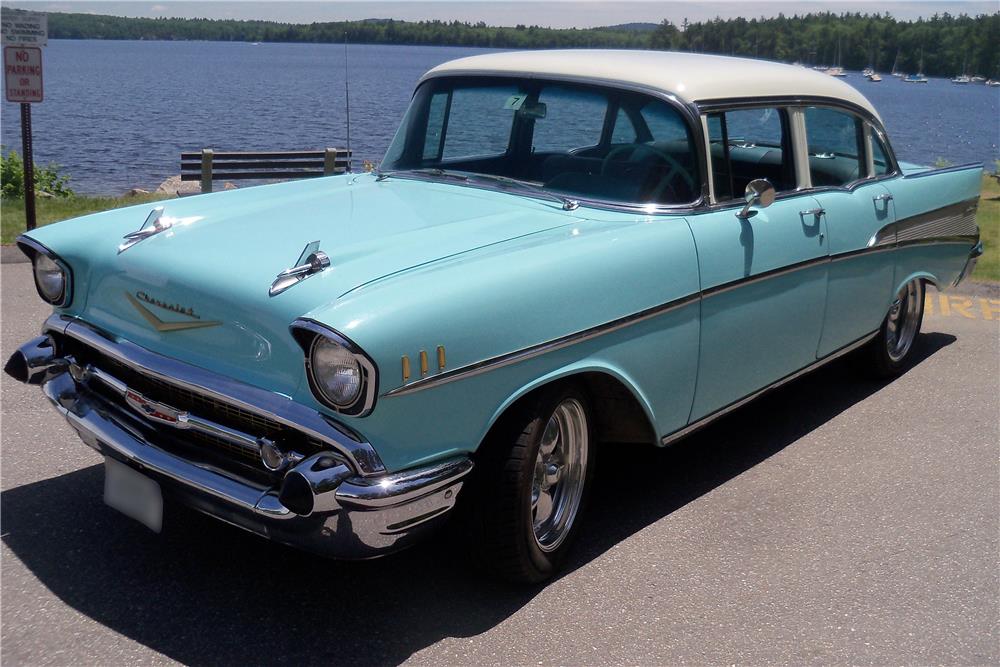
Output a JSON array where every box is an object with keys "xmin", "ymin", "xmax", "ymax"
[{"xmin": 421, "ymin": 49, "xmax": 880, "ymax": 118}]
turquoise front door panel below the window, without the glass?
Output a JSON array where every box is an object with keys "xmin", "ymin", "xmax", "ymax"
[{"xmin": 689, "ymin": 196, "xmax": 828, "ymax": 421}]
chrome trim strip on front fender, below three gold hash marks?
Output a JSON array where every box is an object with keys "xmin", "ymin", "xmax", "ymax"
[{"xmin": 383, "ymin": 293, "xmax": 701, "ymax": 397}]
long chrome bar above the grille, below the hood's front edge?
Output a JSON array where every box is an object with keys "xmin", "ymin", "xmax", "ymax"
[{"xmin": 43, "ymin": 314, "xmax": 385, "ymax": 476}]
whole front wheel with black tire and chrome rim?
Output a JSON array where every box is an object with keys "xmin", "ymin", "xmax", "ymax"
[{"xmin": 472, "ymin": 386, "xmax": 596, "ymax": 583}]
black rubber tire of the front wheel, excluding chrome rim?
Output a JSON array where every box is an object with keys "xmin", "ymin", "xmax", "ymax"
[{"xmin": 467, "ymin": 384, "xmax": 596, "ymax": 584}]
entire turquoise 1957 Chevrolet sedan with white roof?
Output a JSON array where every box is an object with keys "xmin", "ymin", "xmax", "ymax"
[{"xmin": 6, "ymin": 51, "xmax": 982, "ymax": 581}]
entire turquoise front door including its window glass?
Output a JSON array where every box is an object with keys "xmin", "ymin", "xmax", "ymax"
[{"xmin": 689, "ymin": 107, "xmax": 829, "ymax": 421}]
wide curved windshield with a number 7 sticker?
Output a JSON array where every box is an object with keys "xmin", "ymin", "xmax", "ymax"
[{"xmin": 381, "ymin": 77, "xmax": 701, "ymax": 205}]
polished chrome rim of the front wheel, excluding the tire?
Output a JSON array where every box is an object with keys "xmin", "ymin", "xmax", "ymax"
[{"xmin": 531, "ymin": 398, "xmax": 590, "ymax": 552}]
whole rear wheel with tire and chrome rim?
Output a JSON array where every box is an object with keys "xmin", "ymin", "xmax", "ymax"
[{"xmin": 868, "ymin": 279, "xmax": 924, "ymax": 378}]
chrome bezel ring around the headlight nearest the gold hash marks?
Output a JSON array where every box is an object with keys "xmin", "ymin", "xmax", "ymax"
[{"xmin": 290, "ymin": 319, "xmax": 378, "ymax": 417}]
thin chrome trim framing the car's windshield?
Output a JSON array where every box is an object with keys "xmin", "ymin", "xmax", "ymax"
[{"xmin": 395, "ymin": 70, "xmax": 709, "ymax": 215}]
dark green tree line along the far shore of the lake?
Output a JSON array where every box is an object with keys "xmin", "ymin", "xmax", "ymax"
[{"xmin": 13, "ymin": 9, "xmax": 1000, "ymax": 78}]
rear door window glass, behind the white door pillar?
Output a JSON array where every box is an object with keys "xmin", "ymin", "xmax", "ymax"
[{"xmin": 805, "ymin": 107, "xmax": 868, "ymax": 187}]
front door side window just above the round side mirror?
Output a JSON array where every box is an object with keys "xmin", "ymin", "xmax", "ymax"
[{"xmin": 707, "ymin": 107, "xmax": 795, "ymax": 201}]
